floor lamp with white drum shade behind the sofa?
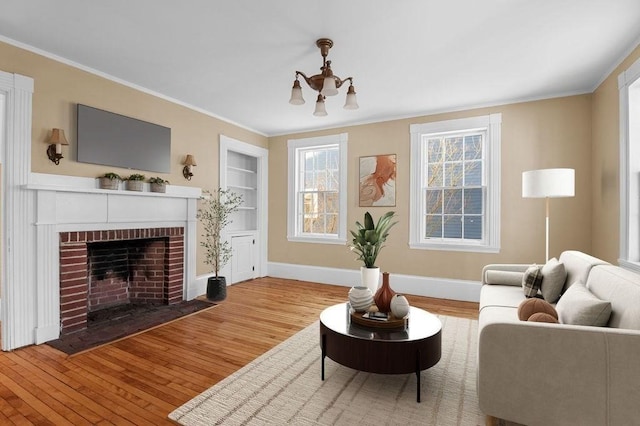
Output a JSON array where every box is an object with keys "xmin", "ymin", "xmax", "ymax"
[{"xmin": 522, "ymin": 169, "xmax": 575, "ymax": 261}]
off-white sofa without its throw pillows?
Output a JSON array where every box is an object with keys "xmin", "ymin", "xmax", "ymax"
[{"xmin": 477, "ymin": 251, "xmax": 640, "ymax": 426}]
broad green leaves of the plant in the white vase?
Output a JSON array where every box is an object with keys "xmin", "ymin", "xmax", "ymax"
[{"xmin": 349, "ymin": 212, "xmax": 398, "ymax": 268}]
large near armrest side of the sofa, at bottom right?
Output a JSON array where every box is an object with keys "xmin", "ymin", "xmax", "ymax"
[{"xmin": 478, "ymin": 322, "xmax": 640, "ymax": 425}]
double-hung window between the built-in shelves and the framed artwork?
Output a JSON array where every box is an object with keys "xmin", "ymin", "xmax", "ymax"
[{"xmin": 287, "ymin": 133, "xmax": 347, "ymax": 244}]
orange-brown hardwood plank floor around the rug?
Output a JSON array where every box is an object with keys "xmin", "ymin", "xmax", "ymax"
[{"xmin": 0, "ymin": 278, "xmax": 478, "ymax": 425}]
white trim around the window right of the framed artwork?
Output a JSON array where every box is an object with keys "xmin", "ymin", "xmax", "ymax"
[{"xmin": 409, "ymin": 113, "xmax": 502, "ymax": 253}]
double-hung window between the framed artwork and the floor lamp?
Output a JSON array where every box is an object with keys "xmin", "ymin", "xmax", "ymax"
[{"xmin": 410, "ymin": 114, "xmax": 502, "ymax": 252}]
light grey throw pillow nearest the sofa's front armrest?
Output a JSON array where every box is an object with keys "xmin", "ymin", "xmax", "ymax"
[{"xmin": 556, "ymin": 281, "xmax": 611, "ymax": 327}]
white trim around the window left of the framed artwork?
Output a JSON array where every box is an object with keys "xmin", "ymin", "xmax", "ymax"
[{"xmin": 287, "ymin": 133, "xmax": 349, "ymax": 245}]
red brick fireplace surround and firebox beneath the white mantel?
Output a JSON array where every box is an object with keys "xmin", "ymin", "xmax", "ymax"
[{"xmin": 60, "ymin": 227, "xmax": 184, "ymax": 334}]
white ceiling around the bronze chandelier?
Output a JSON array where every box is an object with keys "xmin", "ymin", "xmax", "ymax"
[{"xmin": 0, "ymin": 0, "xmax": 640, "ymax": 136}]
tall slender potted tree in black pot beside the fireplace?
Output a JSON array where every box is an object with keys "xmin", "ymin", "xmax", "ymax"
[{"xmin": 197, "ymin": 188, "xmax": 243, "ymax": 301}]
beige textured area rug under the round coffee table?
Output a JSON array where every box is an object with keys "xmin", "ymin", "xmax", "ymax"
[{"xmin": 169, "ymin": 316, "xmax": 485, "ymax": 426}]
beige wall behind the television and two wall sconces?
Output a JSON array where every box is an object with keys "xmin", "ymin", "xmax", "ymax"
[{"xmin": 0, "ymin": 42, "xmax": 268, "ymax": 274}]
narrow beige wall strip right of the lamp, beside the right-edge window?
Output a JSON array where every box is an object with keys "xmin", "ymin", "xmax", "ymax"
[{"xmin": 591, "ymin": 46, "xmax": 640, "ymax": 263}]
